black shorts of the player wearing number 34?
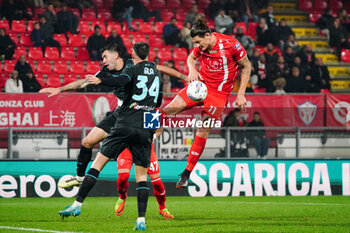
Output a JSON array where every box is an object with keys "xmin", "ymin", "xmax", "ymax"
[{"xmin": 100, "ymin": 127, "xmax": 154, "ymax": 167}]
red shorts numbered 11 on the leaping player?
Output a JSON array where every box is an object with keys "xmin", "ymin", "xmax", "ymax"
[{"xmin": 177, "ymin": 87, "xmax": 229, "ymax": 119}]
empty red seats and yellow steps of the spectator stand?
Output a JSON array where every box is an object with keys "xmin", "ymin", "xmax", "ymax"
[{"xmin": 0, "ymin": 0, "xmax": 350, "ymax": 91}]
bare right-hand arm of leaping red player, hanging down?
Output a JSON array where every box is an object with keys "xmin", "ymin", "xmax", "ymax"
[{"xmin": 236, "ymin": 56, "xmax": 252, "ymax": 112}]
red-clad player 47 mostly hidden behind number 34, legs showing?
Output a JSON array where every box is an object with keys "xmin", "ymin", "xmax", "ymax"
[{"xmin": 115, "ymin": 144, "xmax": 174, "ymax": 219}]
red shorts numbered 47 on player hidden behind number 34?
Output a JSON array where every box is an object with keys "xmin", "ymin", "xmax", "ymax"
[{"xmin": 117, "ymin": 144, "xmax": 159, "ymax": 174}]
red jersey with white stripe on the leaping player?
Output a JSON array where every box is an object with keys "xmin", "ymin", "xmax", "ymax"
[{"xmin": 193, "ymin": 33, "xmax": 247, "ymax": 94}]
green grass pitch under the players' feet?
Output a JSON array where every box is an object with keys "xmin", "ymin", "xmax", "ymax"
[{"xmin": 0, "ymin": 196, "xmax": 350, "ymax": 233}]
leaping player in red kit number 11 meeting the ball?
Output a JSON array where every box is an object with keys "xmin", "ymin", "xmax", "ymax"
[{"xmin": 161, "ymin": 17, "xmax": 251, "ymax": 188}]
